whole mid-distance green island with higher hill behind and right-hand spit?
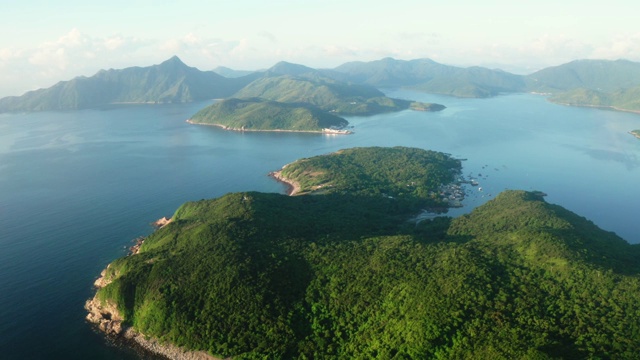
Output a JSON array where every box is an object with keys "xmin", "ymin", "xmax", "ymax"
[{"xmin": 189, "ymin": 73, "xmax": 445, "ymax": 134}]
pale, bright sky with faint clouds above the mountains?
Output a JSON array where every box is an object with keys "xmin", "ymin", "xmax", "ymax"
[{"xmin": 0, "ymin": 0, "xmax": 640, "ymax": 97}]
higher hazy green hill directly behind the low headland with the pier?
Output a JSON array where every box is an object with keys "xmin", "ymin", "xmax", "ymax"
[{"xmin": 234, "ymin": 71, "xmax": 444, "ymax": 115}]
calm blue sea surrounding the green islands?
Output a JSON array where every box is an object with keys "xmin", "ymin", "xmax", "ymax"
[{"xmin": 0, "ymin": 91, "xmax": 640, "ymax": 359}]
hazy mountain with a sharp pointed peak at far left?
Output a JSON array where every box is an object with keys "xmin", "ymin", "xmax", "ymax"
[{"xmin": 0, "ymin": 56, "xmax": 255, "ymax": 112}]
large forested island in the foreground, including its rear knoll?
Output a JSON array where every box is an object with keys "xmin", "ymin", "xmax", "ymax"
[{"xmin": 87, "ymin": 147, "xmax": 640, "ymax": 359}]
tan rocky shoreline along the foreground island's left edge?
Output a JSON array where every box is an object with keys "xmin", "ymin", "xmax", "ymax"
[{"xmin": 84, "ymin": 218, "xmax": 220, "ymax": 360}]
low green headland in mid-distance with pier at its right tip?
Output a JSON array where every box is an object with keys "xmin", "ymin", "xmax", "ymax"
[{"xmin": 191, "ymin": 98, "xmax": 348, "ymax": 131}]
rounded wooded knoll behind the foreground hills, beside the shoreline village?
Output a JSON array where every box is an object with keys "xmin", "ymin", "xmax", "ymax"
[{"xmin": 281, "ymin": 147, "xmax": 461, "ymax": 206}]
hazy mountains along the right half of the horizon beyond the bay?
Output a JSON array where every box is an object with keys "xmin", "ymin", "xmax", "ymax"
[{"xmin": 325, "ymin": 58, "xmax": 640, "ymax": 110}]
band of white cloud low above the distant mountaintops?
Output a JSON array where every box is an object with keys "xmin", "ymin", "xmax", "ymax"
[{"xmin": 0, "ymin": 28, "xmax": 640, "ymax": 97}]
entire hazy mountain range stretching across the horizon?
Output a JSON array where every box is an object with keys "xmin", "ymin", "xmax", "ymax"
[{"xmin": 0, "ymin": 56, "xmax": 640, "ymax": 114}]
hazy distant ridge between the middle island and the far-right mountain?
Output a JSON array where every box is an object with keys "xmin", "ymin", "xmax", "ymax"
[{"xmin": 327, "ymin": 58, "xmax": 526, "ymax": 97}]
